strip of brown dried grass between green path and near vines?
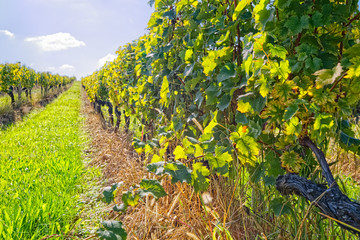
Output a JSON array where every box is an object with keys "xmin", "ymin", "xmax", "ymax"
[{"xmin": 83, "ymin": 88, "xmax": 257, "ymax": 240}]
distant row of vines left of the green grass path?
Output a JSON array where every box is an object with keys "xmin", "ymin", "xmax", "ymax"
[{"xmin": 0, "ymin": 63, "xmax": 75, "ymax": 104}]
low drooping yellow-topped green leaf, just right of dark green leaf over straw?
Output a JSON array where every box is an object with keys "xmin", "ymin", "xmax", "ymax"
[{"xmin": 191, "ymin": 162, "xmax": 210, "ymax": 192}]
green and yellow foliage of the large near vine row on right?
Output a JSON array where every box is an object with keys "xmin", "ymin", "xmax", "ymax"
[{"xmin": 82, "ymin": 0, "xmax": 360, "ymax": 238}]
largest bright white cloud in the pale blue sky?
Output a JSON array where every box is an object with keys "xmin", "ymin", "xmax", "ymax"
[{"xmin": 25, "ymin": 32, "xmax": 86, "ymax": 51}]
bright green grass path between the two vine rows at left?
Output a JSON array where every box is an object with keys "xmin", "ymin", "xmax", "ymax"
[{"xmin": 0, "ymin": 82, "xmax": 86, "ymax": 240}]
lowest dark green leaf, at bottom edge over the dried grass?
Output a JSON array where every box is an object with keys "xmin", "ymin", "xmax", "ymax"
[{"xmin": 97, "ymin": 220, "xmax": 127, "ymax": 240}]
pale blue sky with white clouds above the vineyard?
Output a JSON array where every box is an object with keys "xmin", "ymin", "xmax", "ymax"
[{"xmin": 0, "ymin": 0, "xmax": 153, "ymax": 79}]
